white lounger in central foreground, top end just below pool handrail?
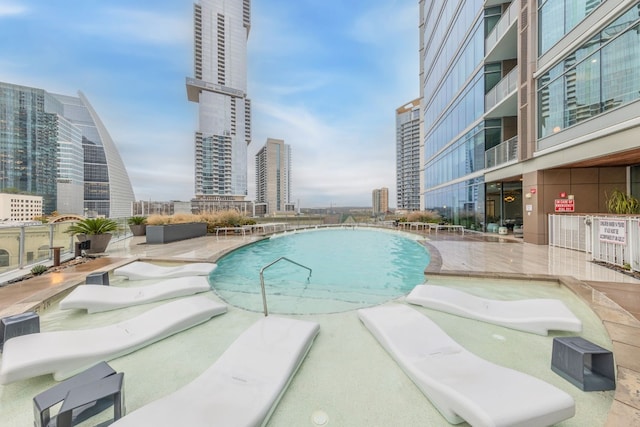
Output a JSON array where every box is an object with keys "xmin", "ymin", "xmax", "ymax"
[{"xmin": 112, "ymin": 316, "xmax": 320, "ymax": 427}]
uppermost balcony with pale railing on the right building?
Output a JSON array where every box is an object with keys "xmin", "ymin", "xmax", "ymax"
[{"xmin": 484, "ymin": 1, "xmax": 520, "ymax": 62}]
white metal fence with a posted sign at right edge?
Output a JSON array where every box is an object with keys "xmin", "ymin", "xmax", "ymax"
[{"xmin": 549, "ymin": 215, "xmax": 640, "ymax": 271}]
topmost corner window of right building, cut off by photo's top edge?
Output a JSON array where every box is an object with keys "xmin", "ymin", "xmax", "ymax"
[{"xmin": 538, "ymin": 0, "xmax": 602, "ymax": 55}]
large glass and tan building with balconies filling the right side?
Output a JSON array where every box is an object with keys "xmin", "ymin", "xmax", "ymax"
[{"xmin": 419, "ymin": 0, "xmax": 640, "ymax": 244}]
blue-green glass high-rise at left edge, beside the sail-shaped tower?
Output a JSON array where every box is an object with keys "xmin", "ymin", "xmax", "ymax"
[{"xmin": 0, "ymin": 83, "xmax": 58, "ymax": 214}]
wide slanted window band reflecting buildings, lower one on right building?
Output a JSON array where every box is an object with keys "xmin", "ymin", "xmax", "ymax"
[{"xmin": 537, "ymin": 5, "xmax": 640, "ymax": 138}]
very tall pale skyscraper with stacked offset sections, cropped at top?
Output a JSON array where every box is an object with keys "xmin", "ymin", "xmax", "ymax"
[{"xmin": 186, "ymin": 0, "xmax": 251, "ymax": 211}]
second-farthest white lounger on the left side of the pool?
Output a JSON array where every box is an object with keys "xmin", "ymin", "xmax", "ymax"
[{"xmin": 60, "ymin": 276, "xmax": 211, "ymax": 313}]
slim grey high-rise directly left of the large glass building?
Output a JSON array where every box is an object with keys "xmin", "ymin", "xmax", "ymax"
[{"xmin": 396, "ymin": 98, "xmax": 421, "ymax": 211}]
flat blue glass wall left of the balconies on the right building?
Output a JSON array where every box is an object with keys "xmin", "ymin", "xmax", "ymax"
[{"xmin": 421, "ymin": 0, "xmax": 482, "ymax": 229}]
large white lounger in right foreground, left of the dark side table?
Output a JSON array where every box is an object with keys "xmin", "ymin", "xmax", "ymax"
[{"xmin": 358, "ymin": 304, "xmax": 575, "ymax": 427}]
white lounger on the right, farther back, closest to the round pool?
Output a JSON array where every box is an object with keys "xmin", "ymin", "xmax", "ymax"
[{"xmin": 406, "ymin": 285, "xmax": 582, "ymax": 335}]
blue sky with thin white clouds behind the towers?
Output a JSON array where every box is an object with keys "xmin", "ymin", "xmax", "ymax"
[{"xmin": 0, "ymin": 0, "xmax": 419, "ymax": 208}]
